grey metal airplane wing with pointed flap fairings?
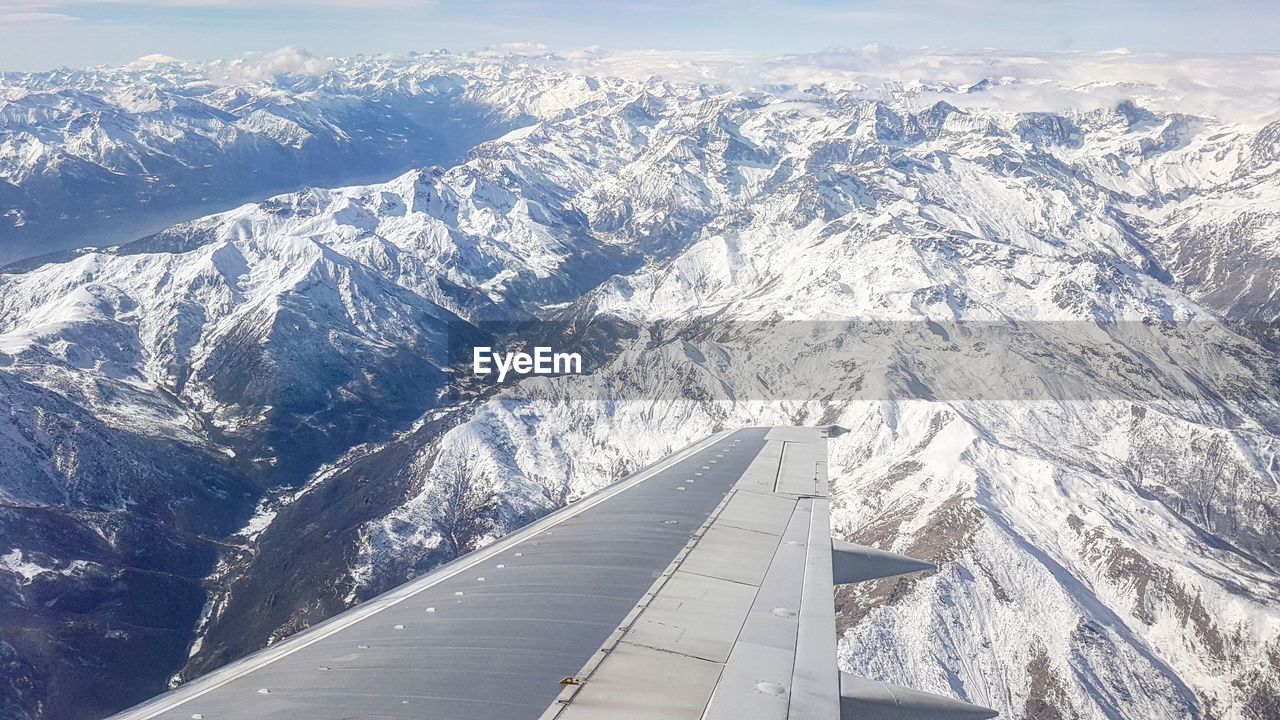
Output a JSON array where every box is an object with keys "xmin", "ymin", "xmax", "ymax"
[{"xmin": 116, "ymin": 427, "xmax": 996, "ymax": 720}]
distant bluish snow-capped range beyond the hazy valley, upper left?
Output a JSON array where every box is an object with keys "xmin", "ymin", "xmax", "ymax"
[{"xmin": 0, "ymin": 49, "xmax": 660, "ymax": 264}]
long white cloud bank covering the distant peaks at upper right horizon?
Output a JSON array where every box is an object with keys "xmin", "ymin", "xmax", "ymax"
[{"xmin": 563, "ymin": 45, "xmax": 1280, "ymax": 124}]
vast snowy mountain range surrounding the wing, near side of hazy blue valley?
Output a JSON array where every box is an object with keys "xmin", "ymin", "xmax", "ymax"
[{"xmin": 0, "ymin": 49, "xmax": 1280, "ymax": 719}]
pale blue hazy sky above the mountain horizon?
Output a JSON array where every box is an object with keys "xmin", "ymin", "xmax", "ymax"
[{"xmin": 0, "ymin": 0, "xmax": 1280, "ymax": 70}]
